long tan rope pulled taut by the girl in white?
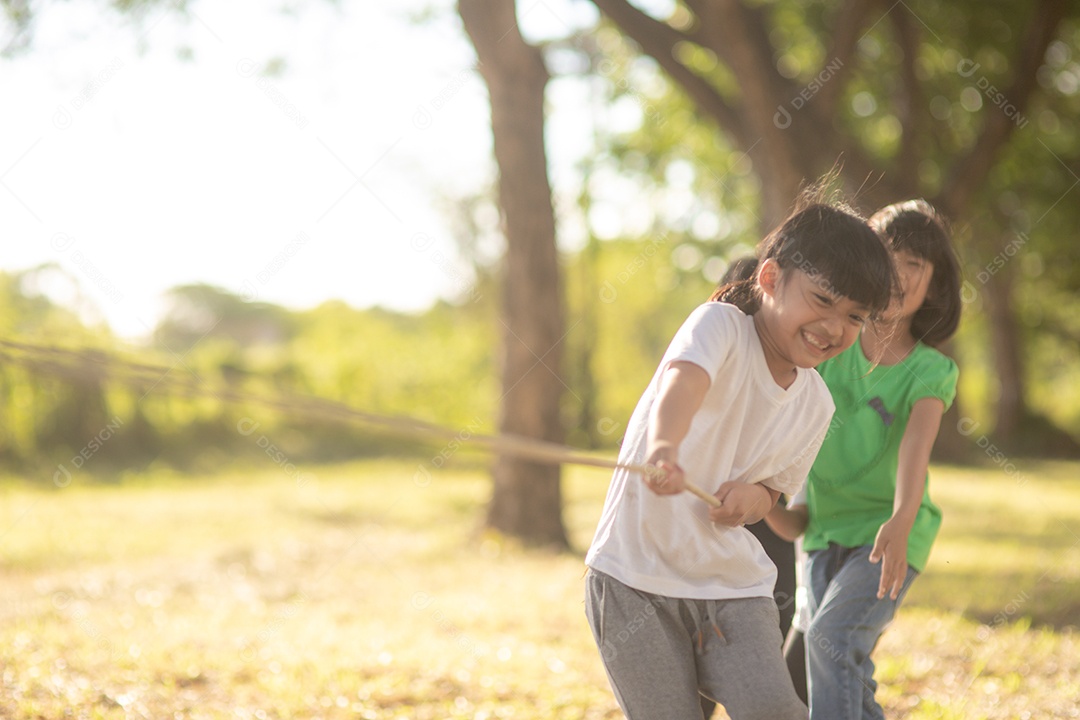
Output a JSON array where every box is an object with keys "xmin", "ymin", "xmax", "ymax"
[{"xmin": 0, "ymin": 340, "xmax": 720, "ymax": 507}]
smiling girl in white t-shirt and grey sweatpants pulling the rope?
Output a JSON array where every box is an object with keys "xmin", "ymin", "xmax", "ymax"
[{"xmin": 585, "ymin": 198, "xmax": 896, "ymax": 720}]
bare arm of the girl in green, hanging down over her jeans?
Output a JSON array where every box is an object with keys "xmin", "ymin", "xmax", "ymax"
[{"xmin": 870, "ymin": 397, "xmax": 945, "ymax": 600}]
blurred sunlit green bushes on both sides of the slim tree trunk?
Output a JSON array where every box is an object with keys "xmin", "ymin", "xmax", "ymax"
[{"xmin": 0, "ymin": 232, "xmax": 739, "ymax": 472}]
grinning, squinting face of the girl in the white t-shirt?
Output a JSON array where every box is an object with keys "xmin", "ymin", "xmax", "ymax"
[{"xmin": 754, "ymin": 260, "xmax": 870, "ymax": 388}]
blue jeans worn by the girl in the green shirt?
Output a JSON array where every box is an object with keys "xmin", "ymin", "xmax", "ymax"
[{"xmin": 805, "ymin": 544, "xmax": 919, "ymax": 720}]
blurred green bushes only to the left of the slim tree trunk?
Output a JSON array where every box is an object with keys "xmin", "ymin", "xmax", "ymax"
[{"xmin": 0, "ymin": 273, "xmax": 497, "ymax": 480}]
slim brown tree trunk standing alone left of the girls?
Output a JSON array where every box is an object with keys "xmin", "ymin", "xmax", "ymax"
[{"xmin": 458, "ymin": 0, "xmax": 568, "ymax": 547}]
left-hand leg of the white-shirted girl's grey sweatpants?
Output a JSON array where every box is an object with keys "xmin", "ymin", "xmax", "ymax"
[{"xmin": 585, "ymin": 570, "xmax": 704, "ymax": 720}]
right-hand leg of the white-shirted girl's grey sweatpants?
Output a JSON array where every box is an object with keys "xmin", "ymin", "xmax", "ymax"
[{"xmin": 695, "ymin": 598, "xmax": 807, "ymax": 720}]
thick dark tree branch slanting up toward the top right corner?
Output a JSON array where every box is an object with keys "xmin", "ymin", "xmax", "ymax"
[{"xmin": 935, "ymin": 0, "xmax": 1067, "ymax": 217}]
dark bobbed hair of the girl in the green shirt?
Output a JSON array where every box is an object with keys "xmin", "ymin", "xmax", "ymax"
[{"xmin": 870, "ymin": 195, "xmax": 963, "ymax": 347}]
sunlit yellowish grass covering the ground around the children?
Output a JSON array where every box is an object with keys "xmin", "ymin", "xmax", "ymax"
[{"xmin": 0, "ymin": 461, "xmax": 1080, "ymax": 720}]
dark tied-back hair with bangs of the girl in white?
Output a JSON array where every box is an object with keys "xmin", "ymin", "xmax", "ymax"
[{"xmin": 710, "ymin": 202, "xmax": 899, "ymax": 318}]
